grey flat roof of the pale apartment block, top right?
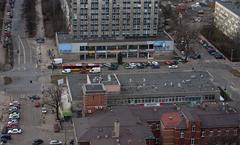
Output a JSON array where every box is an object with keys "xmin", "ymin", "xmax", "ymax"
[{"xmin": 216, "ymin": 0, "xmax": 240, "ymax": 16}]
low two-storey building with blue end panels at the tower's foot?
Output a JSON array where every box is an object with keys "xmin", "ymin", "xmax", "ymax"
[{"xmin": 56, "ymin": 33, "xmax": 174, "ymax": 60}]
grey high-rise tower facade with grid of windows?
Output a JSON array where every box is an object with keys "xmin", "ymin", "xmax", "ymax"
[{"xmin": 69, "ymin": 0, "xmax": 159, "ymax": 38}]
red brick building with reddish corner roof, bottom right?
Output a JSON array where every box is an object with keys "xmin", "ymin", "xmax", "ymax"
[{"xmin": 159, "ymin": 107, "xmax": 240, "ymax": 145}]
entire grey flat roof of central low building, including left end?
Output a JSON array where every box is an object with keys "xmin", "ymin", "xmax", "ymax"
[{"xmin": 68, "ymin": 71, "xmax": 219, "ymax": 99}]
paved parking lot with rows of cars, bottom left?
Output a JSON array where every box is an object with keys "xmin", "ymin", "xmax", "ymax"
[{"xmin": 1, "ymin": 92, "xmax": 73, "ymax": 145}]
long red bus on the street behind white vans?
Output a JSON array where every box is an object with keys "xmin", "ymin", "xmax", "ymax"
[{"xmin": 62, "ymin": 63, "xmax": 101, "ymax": 72}]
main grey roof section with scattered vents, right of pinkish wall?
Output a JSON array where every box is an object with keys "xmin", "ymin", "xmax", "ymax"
[{"xmin": 117, "ymin": 71, "xmax": 219, "ymax": 97}]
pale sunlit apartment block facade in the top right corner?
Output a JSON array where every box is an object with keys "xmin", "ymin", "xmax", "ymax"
[{"xmin": 214, "ymin": 1, "xmax": 240, "ymax": 39}]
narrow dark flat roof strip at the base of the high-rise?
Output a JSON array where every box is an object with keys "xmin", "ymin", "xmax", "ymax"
[{"xmin": 57, "ymin": 33, "xmax": 171, "ymax": 43}]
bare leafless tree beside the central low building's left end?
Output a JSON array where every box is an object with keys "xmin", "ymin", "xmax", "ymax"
[{"xmin": 44, "ymin": 86, "xmax": 62, "ymax": 120}]
